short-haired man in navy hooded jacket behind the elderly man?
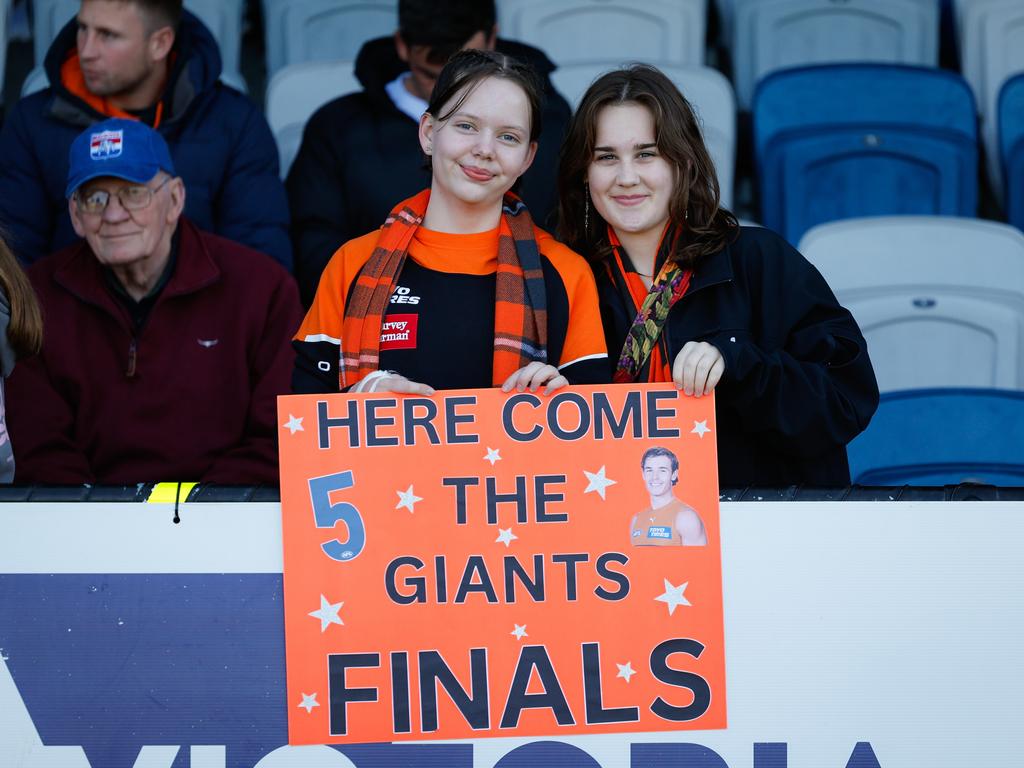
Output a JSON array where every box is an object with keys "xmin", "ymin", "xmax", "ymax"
[{"xmin": 0, "ymin": 0, "xmax": 292, "ymax": 268}]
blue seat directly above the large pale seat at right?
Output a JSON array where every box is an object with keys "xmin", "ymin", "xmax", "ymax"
[{"xmin": 754, "ymin": 63, "xmax": 978, "ymax": 243}]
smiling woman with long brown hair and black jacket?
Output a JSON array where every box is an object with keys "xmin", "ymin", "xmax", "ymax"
[{"xmin": 559, "ymin": 65, "xmax": 879, "ymax": 486}]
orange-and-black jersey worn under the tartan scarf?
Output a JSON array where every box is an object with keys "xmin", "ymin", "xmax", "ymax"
[{"xmin": 292, "ymin": 226, "xmax": 609, "ymax": 393}]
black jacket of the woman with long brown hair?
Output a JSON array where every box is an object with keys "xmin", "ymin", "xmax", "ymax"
[{"xmin": 596, "ymin": 227, "xmax": 879, "ymax": 487}]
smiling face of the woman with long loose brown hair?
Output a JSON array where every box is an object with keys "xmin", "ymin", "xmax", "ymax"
[{"xmin": 587, "ymin": 102, "xmax": 676, "ymax": 243}]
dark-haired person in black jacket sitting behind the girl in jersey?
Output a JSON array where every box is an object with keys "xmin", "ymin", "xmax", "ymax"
[{"xmin": 286, "ymin": 0, "xmax": 570, "ymax": 306}]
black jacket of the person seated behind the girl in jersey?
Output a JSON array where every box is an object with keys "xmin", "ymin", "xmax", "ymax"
[{"xmin": 286, "ymin": 37, "xmax": 570, "ymax": 306}]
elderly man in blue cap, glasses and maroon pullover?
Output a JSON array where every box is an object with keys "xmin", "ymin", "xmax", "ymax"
[{"xmin": 7, "ymin": 119, "xmax": 301, "ymax": 484}]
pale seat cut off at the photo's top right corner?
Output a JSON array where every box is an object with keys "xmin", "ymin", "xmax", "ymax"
[{"xmin": 959, "ymin": 0, "xmax": 1024, "ymax": 199}]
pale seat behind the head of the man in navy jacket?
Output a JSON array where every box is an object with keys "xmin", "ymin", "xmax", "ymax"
[{"xmin": 33, "ymin": 0, "xmax": 246, "ymax": 85}]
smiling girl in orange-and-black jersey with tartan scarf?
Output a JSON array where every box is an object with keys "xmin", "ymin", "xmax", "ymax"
[{"xmin": 293, "ymin": 50, "xmax": 607, "ymax": 394}]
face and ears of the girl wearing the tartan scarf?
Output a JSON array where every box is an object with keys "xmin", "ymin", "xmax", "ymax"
[{"xmin": 420, "ymin": 77, "xmax": 537, "ymax": 211}]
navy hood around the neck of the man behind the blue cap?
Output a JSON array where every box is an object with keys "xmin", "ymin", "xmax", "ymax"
[{"xmin": 43, "ymin": 10, "xmax": 221, "ymax": 128}]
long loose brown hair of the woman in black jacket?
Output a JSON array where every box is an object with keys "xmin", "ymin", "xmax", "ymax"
[{"xmin": 558, "ymin": 63, "xmax": 738, "ymax": 266}]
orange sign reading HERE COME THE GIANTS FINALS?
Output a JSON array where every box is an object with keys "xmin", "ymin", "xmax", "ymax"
[{"xmin": 278, "ymin": 385, "xmax": 726, "ymax": 744}]
